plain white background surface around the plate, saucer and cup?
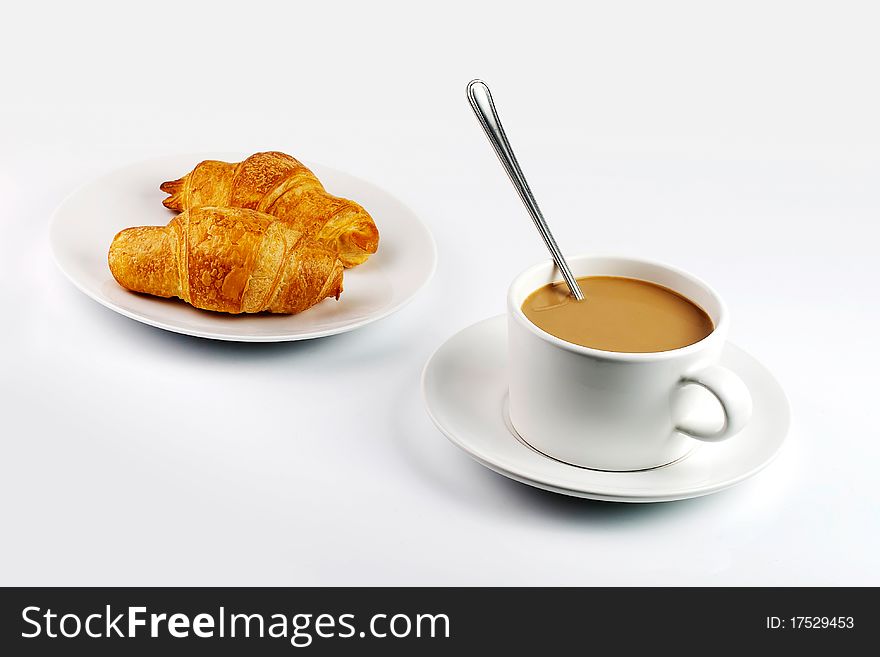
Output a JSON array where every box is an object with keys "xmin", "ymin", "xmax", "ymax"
[{"xmin": 0, "ymin": 0, "xmax": 880, "ymax": 585}]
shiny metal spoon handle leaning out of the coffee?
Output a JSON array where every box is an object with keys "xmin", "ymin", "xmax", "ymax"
[{"xmin": 467, "ymin": 80, "xmax": 584, "ymax": 301}]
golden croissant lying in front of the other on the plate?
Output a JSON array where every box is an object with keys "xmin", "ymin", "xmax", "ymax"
[{"xmin": 108, "ymin": 207, "xmax": 343, "ymax": 313}]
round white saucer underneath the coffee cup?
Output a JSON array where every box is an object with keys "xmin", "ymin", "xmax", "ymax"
[{"xmin": 422, "ymin": 315, "xmax": 789, "ymax": 502}]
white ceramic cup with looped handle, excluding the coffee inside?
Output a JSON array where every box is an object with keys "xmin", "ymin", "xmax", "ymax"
[{"xmin": 507, "ymin": 255, "xmax": 752, "ymax": 471}]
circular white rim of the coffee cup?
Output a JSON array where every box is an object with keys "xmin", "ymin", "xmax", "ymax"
[{"xmin": 507, "ymin": 253, "xmax": 728, "ymax": 362}]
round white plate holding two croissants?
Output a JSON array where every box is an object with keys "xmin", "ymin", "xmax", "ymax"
[{"xmin": 49, "ymin": 153, "xmax": 437, "ymax": 342}]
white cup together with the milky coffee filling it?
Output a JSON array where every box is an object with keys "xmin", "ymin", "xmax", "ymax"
[{"xmin": 507, "ymin": 255, "xmax": 752, "ymax": 471}]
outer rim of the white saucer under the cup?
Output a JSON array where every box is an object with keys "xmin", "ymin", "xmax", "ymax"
[{"xmin": 420, "ymin": 313, "xmax": 791, "ymax": 503}]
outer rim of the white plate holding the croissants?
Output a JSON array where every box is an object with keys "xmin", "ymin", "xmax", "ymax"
[{"xmin": 48, "ymin": 152, "xmax": 438, "ymax": 342}]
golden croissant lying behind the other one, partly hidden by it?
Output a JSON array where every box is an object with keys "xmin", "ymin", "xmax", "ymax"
[{"xmin": 160, "ymin": 152, "xmax": 379, "ymax": 267}]
